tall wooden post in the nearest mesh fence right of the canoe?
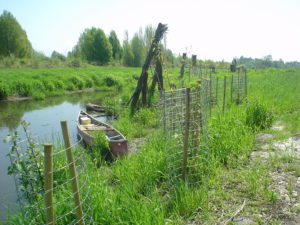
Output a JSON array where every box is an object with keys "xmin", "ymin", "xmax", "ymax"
[{"xmin": 182, "ymin": 88, "xmax": 191, "ymax": 182}]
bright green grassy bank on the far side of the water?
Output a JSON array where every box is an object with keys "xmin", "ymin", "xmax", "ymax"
[{"xmin": 0, "ymin": 66, "xmax": 140, "ymax": 100}]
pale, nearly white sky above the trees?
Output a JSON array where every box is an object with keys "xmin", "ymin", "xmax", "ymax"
[{"xmin": 0, "ymin": 0, "xmax": 300, "ymax": 61}]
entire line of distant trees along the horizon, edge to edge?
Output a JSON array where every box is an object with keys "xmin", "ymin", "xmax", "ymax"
[{"xmin": 0, "ymin": 10, "xmax": 300, "ymax": 69}]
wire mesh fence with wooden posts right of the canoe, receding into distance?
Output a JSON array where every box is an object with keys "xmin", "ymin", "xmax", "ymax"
[{"xmin": 159, "ymin": 64, "xmax": 247, "ymax": 183}]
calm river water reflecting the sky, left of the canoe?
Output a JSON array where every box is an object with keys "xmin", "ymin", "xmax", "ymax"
[{"xmin": 0, "ymin": 92, "xmax": 111, "ymax": 221}]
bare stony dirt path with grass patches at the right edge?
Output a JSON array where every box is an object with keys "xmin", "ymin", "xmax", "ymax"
[{"xmin": 238, "ymin": 123, "xmax": 300, "ymax": 225}]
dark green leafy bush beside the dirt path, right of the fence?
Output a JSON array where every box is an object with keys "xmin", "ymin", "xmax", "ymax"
[{"xmin": 246, "ymin": 100, "xmax": 274, "ymax": 130}]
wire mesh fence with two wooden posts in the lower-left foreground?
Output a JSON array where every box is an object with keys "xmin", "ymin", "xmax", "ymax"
[{"xmin": 10, "ymin": 121, "xmax": 93, "ymax": 224}]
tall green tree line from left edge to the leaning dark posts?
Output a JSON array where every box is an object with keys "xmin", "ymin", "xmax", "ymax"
[{"xmin": 0, "ymin": 11, "xmax": 175, "ymax": 67}]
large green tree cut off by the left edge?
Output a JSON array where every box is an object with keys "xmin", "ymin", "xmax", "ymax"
[{"xmin": 0, "ymin": 11, "xmax": 32, "ymax": 58}]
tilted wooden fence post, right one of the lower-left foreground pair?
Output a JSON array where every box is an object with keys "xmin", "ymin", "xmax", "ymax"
[{"xmin": 60, "ymin": 120, "xmax": 84, "ymax": 225}]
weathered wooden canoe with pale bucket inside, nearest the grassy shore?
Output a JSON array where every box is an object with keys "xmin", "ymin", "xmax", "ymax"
[{"xmin": 77, "ymin": 111, "xmax": 128, "ymax": 156}]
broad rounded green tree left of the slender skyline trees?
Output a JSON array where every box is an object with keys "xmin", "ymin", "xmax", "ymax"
[{"xmin": 74, "ymin": 27, "xmax": 112, "ymax": 64}]
